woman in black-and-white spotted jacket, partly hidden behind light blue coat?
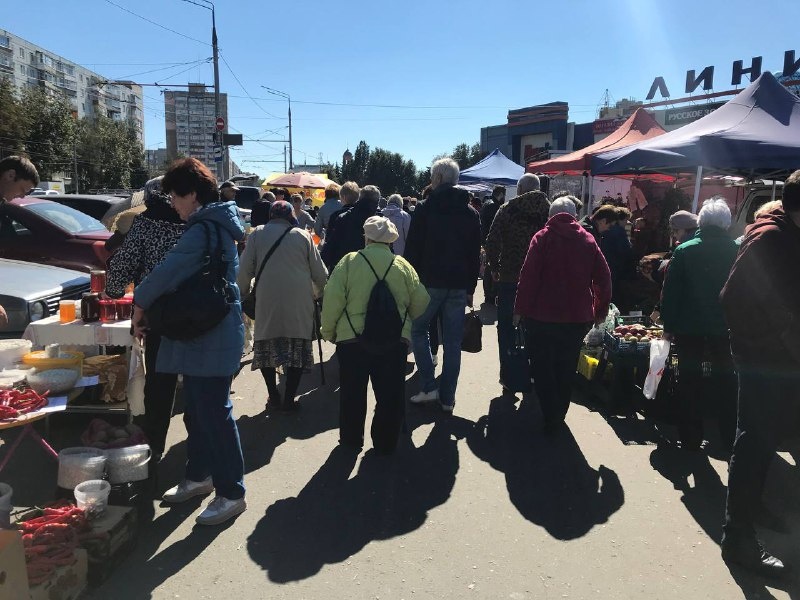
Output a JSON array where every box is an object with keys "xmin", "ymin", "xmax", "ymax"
[{"xmin": 105, "ymin": 177, "xmax": 184, "ymax": 464}]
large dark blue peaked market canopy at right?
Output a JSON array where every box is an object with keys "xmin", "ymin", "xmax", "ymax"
[{"xmin": 591, "ymin": 72, "xmax": 800, "ymax": 177}]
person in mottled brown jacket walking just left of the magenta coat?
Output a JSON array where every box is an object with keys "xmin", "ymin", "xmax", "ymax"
[{"xmin": 481, "ymin": 173, "xmax": 550, "ymax": 387}]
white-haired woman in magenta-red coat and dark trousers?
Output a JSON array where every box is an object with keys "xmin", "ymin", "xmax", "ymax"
[{"xmin": 514, "ymin": 196, "xmax": 611, "ymax": 433}]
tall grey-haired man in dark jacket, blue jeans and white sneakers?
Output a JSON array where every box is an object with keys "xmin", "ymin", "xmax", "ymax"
[{"xmin": 404, "ymin": 158, "xmax": 481, "ymax": 412}]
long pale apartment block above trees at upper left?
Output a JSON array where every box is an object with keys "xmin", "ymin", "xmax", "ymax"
[{"xmin": 0, "ymin": 29, "xmax": 144, "ymax": 144}]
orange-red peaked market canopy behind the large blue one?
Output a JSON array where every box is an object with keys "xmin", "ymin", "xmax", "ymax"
[{"xmin": 526, "ymin": 108, "xmax": 666, "ymax": 175}]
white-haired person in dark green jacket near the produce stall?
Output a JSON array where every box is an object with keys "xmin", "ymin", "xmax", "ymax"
[{"xmin": 661, "ymin": 198, "xmax": 738, "ymax": 453}]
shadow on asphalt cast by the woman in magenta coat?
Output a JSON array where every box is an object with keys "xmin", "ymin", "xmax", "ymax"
[{"xmin": 467, "ymin": 395, "xmax": 625, "ymax": 540}]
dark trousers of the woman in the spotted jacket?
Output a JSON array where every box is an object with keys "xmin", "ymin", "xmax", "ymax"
[{"xmin": 144, "ymin": 333, "xmax": 178, "ymax": 456}]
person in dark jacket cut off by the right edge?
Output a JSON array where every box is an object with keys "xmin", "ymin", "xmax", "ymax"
[{"xmin": 720, "ymin": 171, "xmax": 800, "ymax": 575}]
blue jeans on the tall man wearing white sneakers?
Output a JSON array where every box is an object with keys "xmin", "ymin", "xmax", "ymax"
[{"xmin": 411, "ymin": 288, "xmax": 467, "ymax": 406}]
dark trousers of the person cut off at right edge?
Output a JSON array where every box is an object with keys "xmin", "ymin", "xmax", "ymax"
[{"xmin": 724, "ymin": 365, "xmax": 800, "ymax": 539}]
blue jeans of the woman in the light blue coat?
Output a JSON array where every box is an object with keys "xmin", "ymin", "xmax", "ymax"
[{"xmin": 183, "ymin": 375, "xmax": 244, "ymax": 500}]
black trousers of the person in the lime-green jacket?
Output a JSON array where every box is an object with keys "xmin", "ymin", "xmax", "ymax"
[{"xmin": 336, "ymin": 342, "xmax": 408, "ymax": 454}]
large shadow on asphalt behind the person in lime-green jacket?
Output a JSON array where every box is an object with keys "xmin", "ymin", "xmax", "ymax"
[{"xmin": 247, "ymin": 414, "xmax": 473, "ymax": 583}]
